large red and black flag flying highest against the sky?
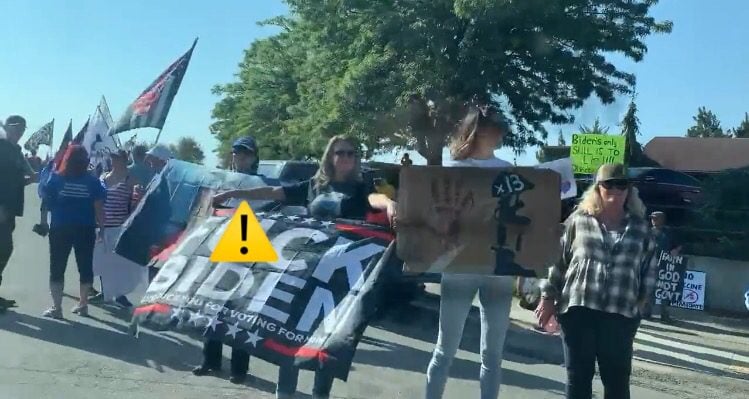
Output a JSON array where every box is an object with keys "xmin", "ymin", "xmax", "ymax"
[{"xmin": 109, "ymin": 39, "xmax": 198, "ymax": 135}]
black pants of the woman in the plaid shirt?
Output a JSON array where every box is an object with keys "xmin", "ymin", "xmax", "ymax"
[{"xmin": 559, "ymin": 307, "xmax": 640, "ymax": 399}]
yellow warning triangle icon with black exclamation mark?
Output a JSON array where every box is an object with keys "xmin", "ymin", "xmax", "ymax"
[{"xmin": 211, "ymin": 201, "xmax": 278, "ymax": 263}]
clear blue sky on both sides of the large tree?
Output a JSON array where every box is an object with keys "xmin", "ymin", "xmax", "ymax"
[{"xmin": 0, "ymin": 0, "xmax": 749, "ymax": 165}]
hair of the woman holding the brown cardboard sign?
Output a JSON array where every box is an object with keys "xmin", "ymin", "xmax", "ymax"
[{"xmin": 450, "ymin": 106, "xmax": 510, "ymax": 161}]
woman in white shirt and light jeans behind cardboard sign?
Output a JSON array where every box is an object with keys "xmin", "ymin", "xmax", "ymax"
[{"xmin": 426, "ymin": 107, "xmax": 513, "ymax": 399}]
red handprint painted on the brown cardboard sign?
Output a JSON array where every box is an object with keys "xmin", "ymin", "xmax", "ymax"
[{"xmin": 427, "ymin": 177, "xmax": 474, "ymax": 247}]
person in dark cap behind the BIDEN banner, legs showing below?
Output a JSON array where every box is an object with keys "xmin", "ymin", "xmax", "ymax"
[{"xmin": 192, "ymin": 136, "xmax": 260, "ymax": 384}]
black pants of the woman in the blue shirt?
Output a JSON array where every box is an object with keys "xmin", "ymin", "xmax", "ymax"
[{"xmin": 49, "ymin": 226, "xmax": 96, "ymax": 284}]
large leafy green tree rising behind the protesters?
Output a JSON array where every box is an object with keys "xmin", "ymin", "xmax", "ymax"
[{"xmin": 212, "ymin": 0, "xmax": 671, "ymax": 164}]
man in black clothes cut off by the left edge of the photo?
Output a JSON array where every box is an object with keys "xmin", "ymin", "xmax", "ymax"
[{"xmin": 0, "ymin": 115, "xmax": 35, "ymax": 311}]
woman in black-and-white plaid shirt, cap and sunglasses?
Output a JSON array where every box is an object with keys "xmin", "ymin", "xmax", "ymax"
[{"xmin": 536, "ymin": 164, "xmax": 658, "ymax": 399}]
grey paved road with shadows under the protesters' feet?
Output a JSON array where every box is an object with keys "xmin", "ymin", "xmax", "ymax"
[{"xmin": 0, "ymin": 188, "xmax": 724, "ymax": 399}]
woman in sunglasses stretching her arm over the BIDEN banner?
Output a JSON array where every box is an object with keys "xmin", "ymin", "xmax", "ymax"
[{"xmin": 214, "ymin": 136, "xmax": 395, "ymax": 399}]
